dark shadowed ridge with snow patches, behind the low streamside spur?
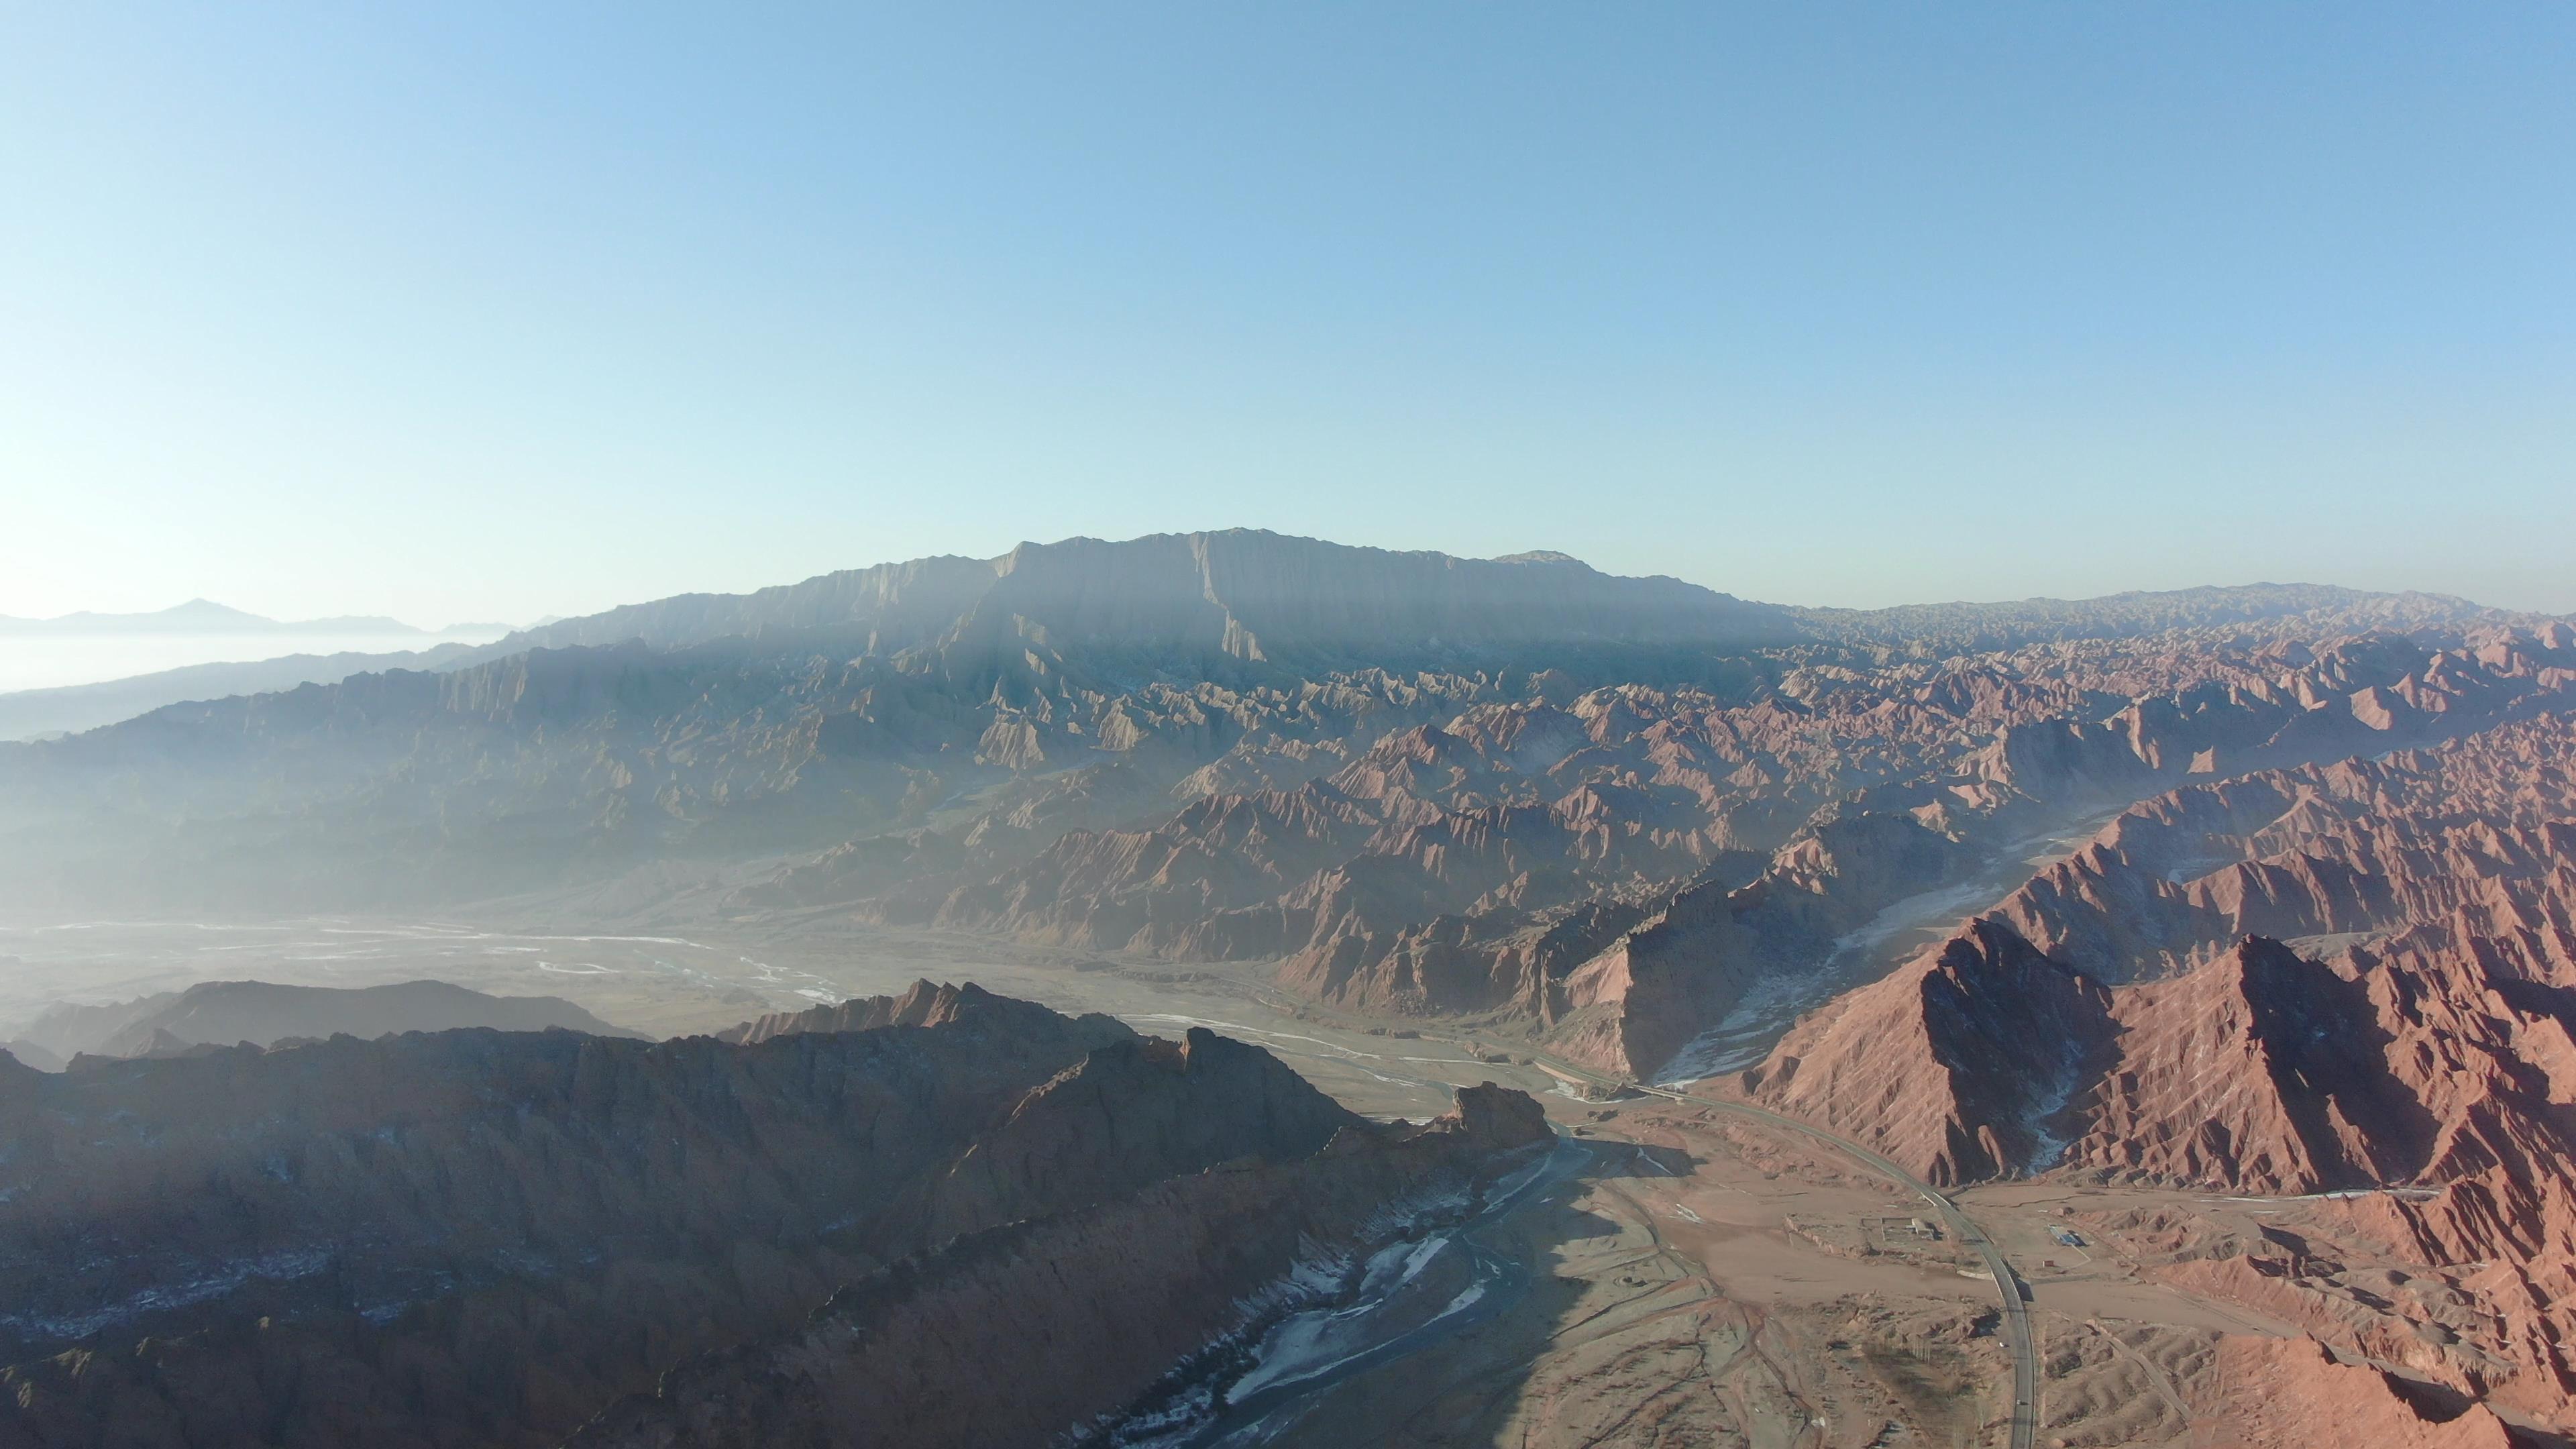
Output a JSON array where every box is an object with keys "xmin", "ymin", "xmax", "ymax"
[{"xmin": 0, "ymin": 982, "xmax": 1473, "ymax": 1446}]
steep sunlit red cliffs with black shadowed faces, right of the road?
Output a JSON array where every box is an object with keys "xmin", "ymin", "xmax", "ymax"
[{"xmin": 1733, "ymin": 902, "xmax": 2576, "ymax": 1206}]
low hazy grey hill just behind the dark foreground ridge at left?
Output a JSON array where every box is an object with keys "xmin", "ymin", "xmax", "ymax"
[{"xmin": 0, "ymin": 979, "xmax": 641, "ymax": 1067}]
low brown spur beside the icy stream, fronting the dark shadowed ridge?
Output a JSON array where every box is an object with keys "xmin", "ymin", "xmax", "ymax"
[{"xmin": 574, "ymin": 1085, "xmax": 1548, "ymax": 1449}]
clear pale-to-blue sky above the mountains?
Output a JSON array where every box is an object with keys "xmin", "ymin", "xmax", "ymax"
[{"xmin": 0, "ymin": 0, "xmax": 2576, "ymax": 624}]
